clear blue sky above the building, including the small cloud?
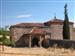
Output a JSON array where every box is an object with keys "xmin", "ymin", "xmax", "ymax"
[{"xmin": 0, "ymin": 0, "xmax": 75, "ymax": 27}]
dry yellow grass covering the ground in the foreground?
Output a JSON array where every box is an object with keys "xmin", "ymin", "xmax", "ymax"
[{"xmin": 0, "ymin": 46, "xmax": 75, "ymax": 56}]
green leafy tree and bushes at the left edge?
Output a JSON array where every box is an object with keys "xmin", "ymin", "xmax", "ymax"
[{"xmin": 0, "ymin": 26, "xmax": 15, "ymax": 46}]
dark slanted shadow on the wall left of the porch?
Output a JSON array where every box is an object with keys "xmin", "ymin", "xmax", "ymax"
[{"xmin": 15, "ymin": 34, "xmax": 29, "ymax": 47}]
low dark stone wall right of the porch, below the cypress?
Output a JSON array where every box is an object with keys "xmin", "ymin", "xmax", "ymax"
[{"xmin": 49, "ymin": 39, "xmax": 75, "ymax": 48}]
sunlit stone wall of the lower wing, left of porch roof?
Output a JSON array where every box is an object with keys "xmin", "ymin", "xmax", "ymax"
[{"xmin": 10, "ymin": 28, "xmax": 31, "ymax": 41}]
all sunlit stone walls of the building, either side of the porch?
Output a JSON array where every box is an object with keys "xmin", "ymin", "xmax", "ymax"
[{"xmin": 10, "ymin": 24, "xmax": 75, "ymax": 41}]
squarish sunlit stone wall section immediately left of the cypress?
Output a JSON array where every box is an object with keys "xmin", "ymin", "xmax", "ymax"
[{"xmin": 51, "ymin": 25, "xmax": 63, "ymax": 39}]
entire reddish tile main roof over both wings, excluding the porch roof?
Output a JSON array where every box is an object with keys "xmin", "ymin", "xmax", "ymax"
[{"xmin": 10, "ymin": 19, "xmax": 73, "ymax": 28}]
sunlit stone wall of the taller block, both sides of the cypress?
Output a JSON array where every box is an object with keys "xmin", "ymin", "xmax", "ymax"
[{"xmin": 50, "ymin": 24, "xmax": 75, "ymax": 40}]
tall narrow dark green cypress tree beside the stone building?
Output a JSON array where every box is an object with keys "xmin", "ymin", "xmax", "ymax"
[{"xmin": 63, "ymin": 4, "xmax": 70, "ymax": 39}]
